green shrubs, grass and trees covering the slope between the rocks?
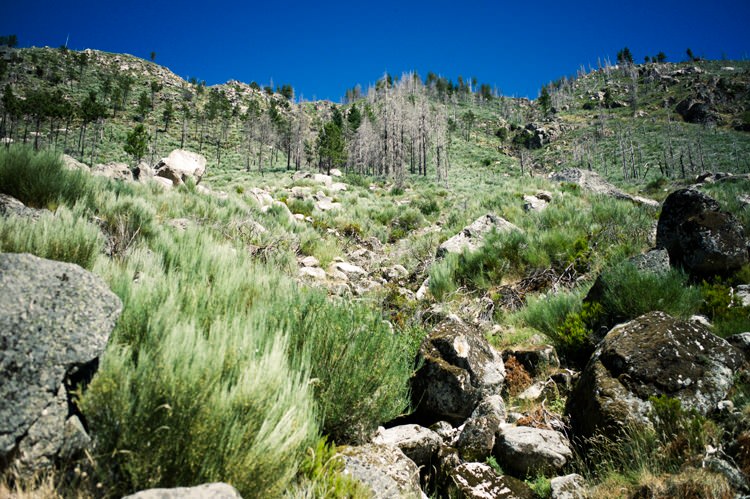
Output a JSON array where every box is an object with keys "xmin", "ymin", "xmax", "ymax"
[{"xmin": 0, "ymin": 41, "xmax": 750, "ymax": 497}]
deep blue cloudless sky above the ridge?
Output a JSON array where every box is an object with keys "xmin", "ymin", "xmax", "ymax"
[{"xmin": 0, "ymin": 0, "xmax": 750, "ymax": 101}]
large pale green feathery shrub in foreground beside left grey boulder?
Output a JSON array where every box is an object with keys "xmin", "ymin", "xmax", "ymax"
[{"xmin": 81, "ymin": 320, "xmax": 316, "ymax": 497}]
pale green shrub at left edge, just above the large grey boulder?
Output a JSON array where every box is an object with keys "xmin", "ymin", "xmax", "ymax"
[{"xmin": 0, "ymin": 207, "xmax": 104, "ymax": 269}]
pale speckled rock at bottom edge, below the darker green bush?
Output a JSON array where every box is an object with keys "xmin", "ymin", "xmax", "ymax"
[{"xmin": 340, "ymin": 444, "xmax": 422, "ymax": 499}]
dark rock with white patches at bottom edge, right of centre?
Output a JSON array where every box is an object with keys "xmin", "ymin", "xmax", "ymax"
[{"xmin": 448, "ymin": 463, "xmax": 536, "ymax": 499}]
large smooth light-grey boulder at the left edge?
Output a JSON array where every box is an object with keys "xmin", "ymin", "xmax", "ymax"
[{"xmin": 0, "ymin": 253, "xmax": 122, "ymax": 472}]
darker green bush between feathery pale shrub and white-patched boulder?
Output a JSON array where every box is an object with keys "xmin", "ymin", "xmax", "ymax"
[{"xmin": 266, "ymin": 292, "xmax": 413, "ymax": 443}]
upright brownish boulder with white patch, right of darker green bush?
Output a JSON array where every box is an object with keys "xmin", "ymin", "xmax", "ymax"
[{"xmin": 412, "ymin": 321, "xmax": 505, "ymax": 424}]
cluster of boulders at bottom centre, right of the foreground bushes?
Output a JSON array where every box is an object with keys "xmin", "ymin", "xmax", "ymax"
[{"xmin": 341, "ymin": 320, "xmax": 583, "ymax": 498}]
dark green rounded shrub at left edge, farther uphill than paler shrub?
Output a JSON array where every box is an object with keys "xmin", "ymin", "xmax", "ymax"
[{"xmin": 0, "ymin": 147, "xmax": 91, "ymax": 209}]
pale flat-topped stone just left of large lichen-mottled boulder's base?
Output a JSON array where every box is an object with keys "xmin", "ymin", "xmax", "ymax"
[{"xmin": 495, "ymin": 425, "xmax": 573, "ymax": 477}]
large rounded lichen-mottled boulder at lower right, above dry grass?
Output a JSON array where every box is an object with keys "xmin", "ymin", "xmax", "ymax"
[{"xmin": 566, "ymin": 312, "xmax": 743, "ymax": 438}]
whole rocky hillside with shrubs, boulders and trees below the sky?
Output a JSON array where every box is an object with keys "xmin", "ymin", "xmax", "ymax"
[{"xmin": 0, "ymin": 44, "xmax": 750, "ymax": 498}]
